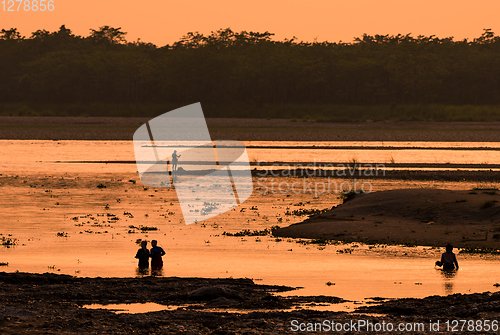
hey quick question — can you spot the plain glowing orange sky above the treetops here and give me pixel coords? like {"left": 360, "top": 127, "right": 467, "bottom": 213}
{"left": 0, "top": 0, "right": 500, "bottom": 46}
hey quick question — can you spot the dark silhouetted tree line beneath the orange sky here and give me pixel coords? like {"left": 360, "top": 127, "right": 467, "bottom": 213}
{"left": 0, "top": 26, "right": 500, "bottom": 117}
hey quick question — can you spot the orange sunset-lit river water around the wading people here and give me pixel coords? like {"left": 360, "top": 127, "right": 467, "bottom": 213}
{"left": 0, "top": 141, "right": 500, "bottom": 310}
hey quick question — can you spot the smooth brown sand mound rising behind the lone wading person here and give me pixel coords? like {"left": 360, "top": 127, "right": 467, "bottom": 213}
{"left": 273, "top": 189, "right": 500, "bottom": 249}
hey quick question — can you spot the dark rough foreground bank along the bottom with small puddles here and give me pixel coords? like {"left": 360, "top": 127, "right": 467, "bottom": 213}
{"left": 0, "top": 273, "right": 500, "bottom": 334}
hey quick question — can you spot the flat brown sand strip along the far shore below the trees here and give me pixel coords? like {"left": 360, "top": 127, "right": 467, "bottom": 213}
{"left": 0, "top": 116, "right": 500, "bottom": 142}
